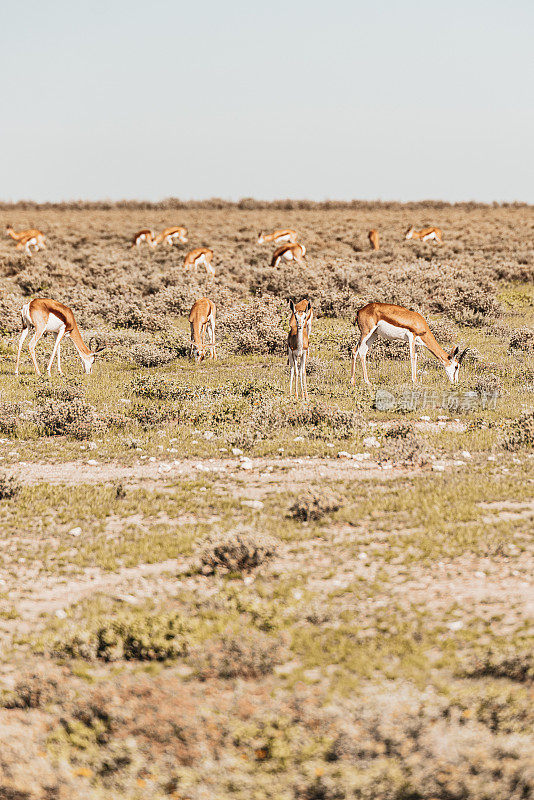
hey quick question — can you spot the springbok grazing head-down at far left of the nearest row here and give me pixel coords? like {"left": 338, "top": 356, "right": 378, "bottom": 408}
{"left": 15, "top": 297, "right": 105, "bottom": 375}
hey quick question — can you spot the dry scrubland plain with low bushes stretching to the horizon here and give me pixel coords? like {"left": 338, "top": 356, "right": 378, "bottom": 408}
{"left": 0, "top": 200, "right": 534, "bottom": 800}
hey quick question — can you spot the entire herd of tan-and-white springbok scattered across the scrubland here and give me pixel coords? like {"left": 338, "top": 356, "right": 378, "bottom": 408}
{"left": 7, "top": 226, "right": 467, "bottom": 400}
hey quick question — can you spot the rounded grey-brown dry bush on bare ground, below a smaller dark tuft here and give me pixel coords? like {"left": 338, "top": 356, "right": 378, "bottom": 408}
{"left": 198, "top": 532, "right": 277, "bottom": 575}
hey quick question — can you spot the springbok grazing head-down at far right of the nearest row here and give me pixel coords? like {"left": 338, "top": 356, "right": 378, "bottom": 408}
{"left": 350, "top": 303, "right": 467, "bottom": 385}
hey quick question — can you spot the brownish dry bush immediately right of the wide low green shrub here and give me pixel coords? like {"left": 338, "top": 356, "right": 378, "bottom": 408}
{"left": 189, "top": 629, "right": 288, "bottom": 680}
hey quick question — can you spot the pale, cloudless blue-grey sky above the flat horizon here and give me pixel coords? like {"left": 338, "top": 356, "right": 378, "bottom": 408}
{"left": 0, "top": 0, "right": 534, "bottom": 202}
